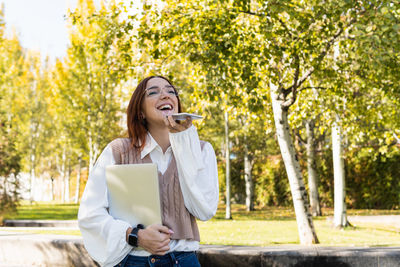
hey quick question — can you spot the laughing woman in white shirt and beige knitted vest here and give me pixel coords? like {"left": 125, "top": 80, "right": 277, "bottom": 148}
{"left": 78, "top": 76, "right": 218, "bottom": 266}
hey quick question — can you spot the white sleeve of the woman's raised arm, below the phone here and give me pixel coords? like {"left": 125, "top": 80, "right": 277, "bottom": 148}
{"left": 169, "top": 126, "right": 219, "bottom": 221}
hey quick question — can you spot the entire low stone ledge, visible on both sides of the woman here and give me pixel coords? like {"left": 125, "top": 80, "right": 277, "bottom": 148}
{"left": 0, "top": 236, "right": 400, "bottom": 267}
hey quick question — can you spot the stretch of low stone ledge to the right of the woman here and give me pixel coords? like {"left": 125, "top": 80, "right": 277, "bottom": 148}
{"left": 198, "top": 245, "right": 400, "bottom": 267}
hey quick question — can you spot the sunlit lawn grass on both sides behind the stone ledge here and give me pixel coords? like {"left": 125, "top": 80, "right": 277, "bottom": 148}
{"left": 1, "top": 203, "right": 400, "bottom": 246}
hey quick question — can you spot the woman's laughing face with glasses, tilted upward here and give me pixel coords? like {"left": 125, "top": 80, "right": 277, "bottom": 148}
{"left": 142, "top": 77, "right": 178, "bottom": 125}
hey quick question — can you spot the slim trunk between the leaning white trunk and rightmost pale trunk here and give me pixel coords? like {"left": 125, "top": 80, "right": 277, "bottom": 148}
{"left": 306, "top": 120, "right": 321, "bottom": 216}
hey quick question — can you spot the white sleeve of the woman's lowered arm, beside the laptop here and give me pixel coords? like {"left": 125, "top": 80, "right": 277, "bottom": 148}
{"left": 78, "top": 145, "right": 132, "bottom": 266}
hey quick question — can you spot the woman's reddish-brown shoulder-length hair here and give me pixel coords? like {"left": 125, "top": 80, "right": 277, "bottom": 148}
{"left": 126, "top": 76, "right": 182, "bottom": 151}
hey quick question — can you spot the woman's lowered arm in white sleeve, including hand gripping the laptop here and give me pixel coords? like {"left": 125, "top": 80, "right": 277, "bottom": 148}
{"left": 78, "top": 145, "right": 171, "bottom": 266}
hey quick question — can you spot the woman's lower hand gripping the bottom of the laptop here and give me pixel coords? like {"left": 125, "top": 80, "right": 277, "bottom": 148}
{"left": 138, "top": 224, "right": 173, "bottom": 255}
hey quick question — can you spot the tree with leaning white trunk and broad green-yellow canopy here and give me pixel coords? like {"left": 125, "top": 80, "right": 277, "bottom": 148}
{"left": 130, "top": 0, "right": 400, "bottom": 244}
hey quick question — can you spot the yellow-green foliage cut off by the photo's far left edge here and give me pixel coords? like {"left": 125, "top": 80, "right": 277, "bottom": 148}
{"left": 0, "top": 10, "right": 23, "bottom": 217}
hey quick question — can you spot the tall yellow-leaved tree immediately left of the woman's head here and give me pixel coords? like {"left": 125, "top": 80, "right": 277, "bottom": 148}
{"left": 61, "top": 0, "right": 132, "bottom": 174}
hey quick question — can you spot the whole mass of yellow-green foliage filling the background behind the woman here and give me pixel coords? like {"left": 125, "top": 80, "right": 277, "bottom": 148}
{"left": 0, "top": 0, "right": 400, "bottom": 215}
